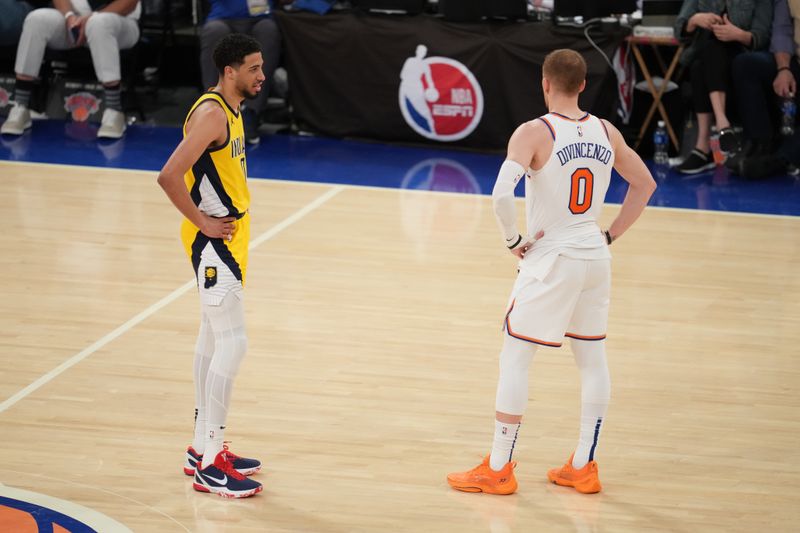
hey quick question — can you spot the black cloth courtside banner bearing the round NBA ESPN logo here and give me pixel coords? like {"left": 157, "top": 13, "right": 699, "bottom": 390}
{"left": 276, "top": 12, "right": 622, "bottom": 150}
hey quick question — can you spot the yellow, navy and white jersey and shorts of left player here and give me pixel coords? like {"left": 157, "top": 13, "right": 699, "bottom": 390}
{"left": 181, "top": 91, "right": 250, "bottom": 290}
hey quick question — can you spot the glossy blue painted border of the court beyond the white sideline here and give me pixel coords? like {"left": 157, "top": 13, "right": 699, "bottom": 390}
{"left": 0, "top": 120, "right": 800, "bottom": 216}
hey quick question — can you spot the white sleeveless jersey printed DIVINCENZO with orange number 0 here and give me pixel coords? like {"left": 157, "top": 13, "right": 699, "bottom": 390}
{"left": 520, "top": 113, "right": 614, "bottom": 277}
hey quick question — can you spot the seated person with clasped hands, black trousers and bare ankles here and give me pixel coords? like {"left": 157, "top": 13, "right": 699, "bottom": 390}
{"left": 675, "top": 0, "right": 773, "bottom": 174}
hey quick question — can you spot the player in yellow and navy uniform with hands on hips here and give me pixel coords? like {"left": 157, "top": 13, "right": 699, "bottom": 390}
{"left": 158, "top": 34, "right": 264, "bottom": 498}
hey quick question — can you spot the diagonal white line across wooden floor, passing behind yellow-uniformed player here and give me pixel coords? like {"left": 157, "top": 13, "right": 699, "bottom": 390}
{"left": 0, "top": 185, "right": 344, "bottom": 413}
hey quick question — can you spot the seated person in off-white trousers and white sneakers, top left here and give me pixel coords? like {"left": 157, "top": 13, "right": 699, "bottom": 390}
{"left": 0, "top": 0, "right": 141, "bottom": 139}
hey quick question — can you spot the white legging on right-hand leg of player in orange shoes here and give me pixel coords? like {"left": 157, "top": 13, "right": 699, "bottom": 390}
{"left": 572, "top": 339, "right": 611, "bottom": 469}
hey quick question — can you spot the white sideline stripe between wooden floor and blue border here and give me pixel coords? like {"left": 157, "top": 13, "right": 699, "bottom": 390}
{"left": 0, "top": 159, "right": 800, "bottom": 220}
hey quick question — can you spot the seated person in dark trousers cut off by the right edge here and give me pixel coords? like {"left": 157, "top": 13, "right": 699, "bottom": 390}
{"left": 726, "top": 0, "right": 800, "bottom": 175}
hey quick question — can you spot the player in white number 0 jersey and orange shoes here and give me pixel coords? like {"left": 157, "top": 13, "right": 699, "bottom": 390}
{"left": 447, "top": 50, "right": 656, "bottom": 494}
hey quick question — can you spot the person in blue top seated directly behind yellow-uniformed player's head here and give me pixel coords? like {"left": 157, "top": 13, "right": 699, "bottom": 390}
{"left": 200, "top": 0, "right": 293, "bottom": 144}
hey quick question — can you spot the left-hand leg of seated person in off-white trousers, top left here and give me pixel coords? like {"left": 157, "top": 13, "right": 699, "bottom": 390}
{"left": 0, "top": 8, "right": 72, "bottom": 135}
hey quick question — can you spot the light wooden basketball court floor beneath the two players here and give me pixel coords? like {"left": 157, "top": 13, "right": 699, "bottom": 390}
{"left": 0, "top": 162, "right": 800, "bottom": 532}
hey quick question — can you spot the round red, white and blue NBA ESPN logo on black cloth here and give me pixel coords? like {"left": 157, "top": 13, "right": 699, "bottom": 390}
{"left": 399, "top": 44, "right": 483, "bottom": 141}
